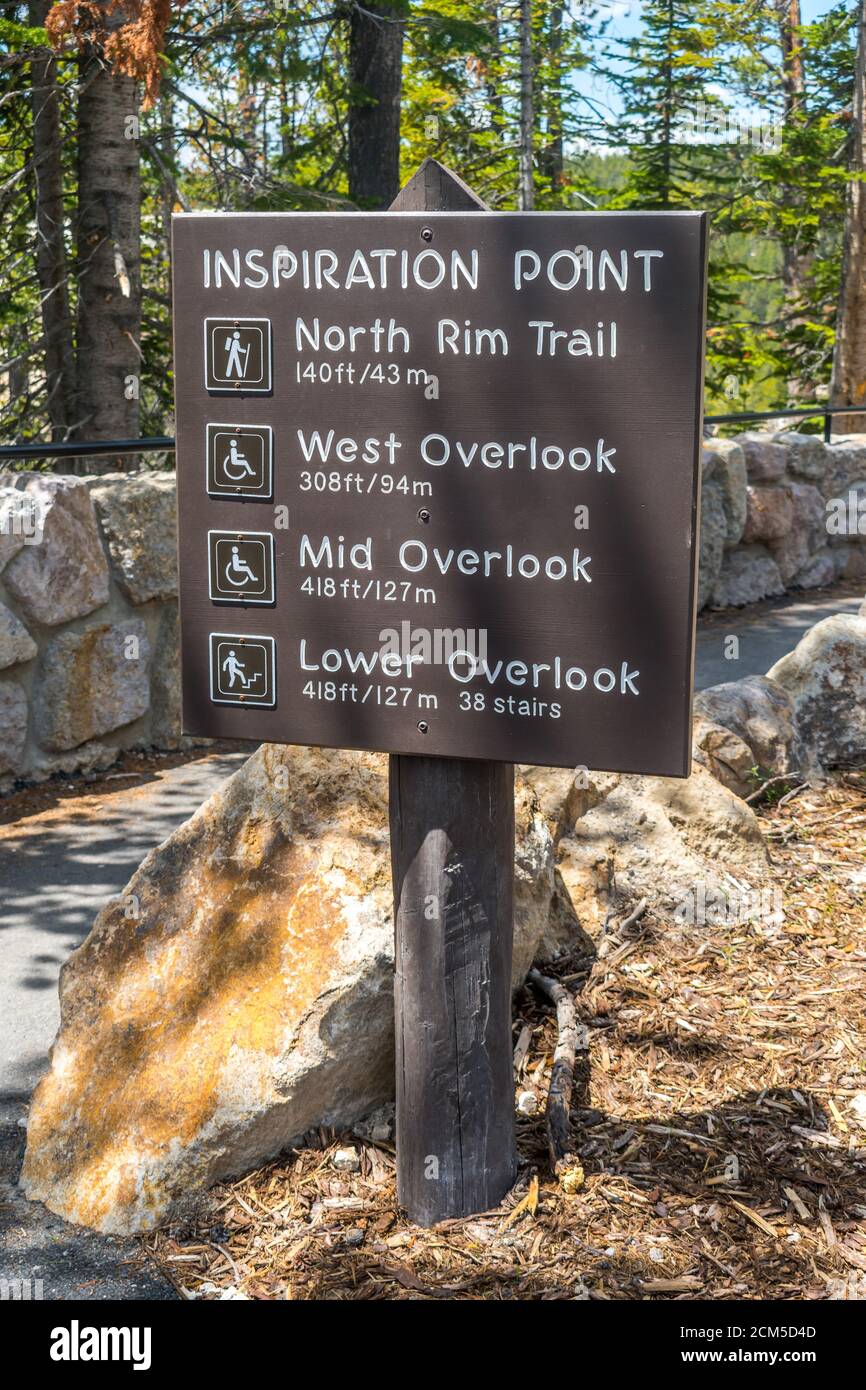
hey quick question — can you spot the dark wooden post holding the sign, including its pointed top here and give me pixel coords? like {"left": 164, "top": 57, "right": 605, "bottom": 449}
{"left": 389, "top": 160, "right": 517, "bottom": 1226}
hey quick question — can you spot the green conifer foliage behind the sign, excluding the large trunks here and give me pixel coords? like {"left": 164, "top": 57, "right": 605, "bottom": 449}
{"left": 0, "top": 0, "right": 855, "bottom": 441}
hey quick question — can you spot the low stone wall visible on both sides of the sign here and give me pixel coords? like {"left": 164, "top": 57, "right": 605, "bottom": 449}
{"left": 0, "top": 434, "right": 866, "bottom": 791}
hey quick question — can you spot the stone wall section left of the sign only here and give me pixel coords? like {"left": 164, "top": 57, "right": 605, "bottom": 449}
{"left": 0, "top": 473, "right": 179, "bottom": 791}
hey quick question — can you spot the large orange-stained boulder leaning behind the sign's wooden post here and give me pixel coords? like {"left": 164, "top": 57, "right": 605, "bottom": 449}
{"left": 22, "top": 745, "right": 553, "bottom": 1232}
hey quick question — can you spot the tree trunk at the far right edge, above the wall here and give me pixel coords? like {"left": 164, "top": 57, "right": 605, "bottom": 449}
{"left": 833, "top": 0, "right": 866, "bottom": 434}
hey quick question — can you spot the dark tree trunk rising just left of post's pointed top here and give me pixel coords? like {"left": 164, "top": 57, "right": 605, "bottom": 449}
{"left": 349, "top": 0, "right": 403, "bottom": 209}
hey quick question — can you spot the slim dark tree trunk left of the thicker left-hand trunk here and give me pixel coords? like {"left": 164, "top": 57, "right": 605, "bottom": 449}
{"left": 29, "top": 0, "right": 75, "bottom": 439}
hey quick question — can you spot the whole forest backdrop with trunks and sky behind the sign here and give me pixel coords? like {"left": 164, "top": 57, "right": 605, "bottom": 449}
{"left": 0, "top": 0, "right": 866, "bottom": 471}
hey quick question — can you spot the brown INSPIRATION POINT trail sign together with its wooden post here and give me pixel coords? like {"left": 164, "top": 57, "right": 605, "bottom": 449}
{"left": 174, "top": 160, "right": 706, "bottom": 1222}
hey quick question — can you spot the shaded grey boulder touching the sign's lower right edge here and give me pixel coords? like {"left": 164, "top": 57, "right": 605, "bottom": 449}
{"left": 694, "top": 676, "right": 808, "bottom": 796}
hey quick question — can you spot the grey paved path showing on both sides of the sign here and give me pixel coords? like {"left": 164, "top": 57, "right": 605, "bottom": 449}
{"left": 0, "top": 581, "right": 862, "bottom": 1298}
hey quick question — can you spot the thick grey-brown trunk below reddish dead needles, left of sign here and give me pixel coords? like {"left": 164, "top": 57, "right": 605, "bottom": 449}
{"left": 78, "top": 5, "right": 142, "bottom": 473}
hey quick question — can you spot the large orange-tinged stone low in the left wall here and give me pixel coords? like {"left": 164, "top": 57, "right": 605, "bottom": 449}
{"left": 38, "top": 617, "right": 150, "bottom": 752}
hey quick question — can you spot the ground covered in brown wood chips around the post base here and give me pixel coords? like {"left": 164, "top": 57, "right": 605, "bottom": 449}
{"left": 143, "top": 773, "right": 866, "bottom": 1300}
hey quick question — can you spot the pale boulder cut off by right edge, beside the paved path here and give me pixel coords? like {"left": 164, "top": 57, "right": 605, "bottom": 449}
{"left": 767, "top": 613, "right": 866, "bottom": 767}
